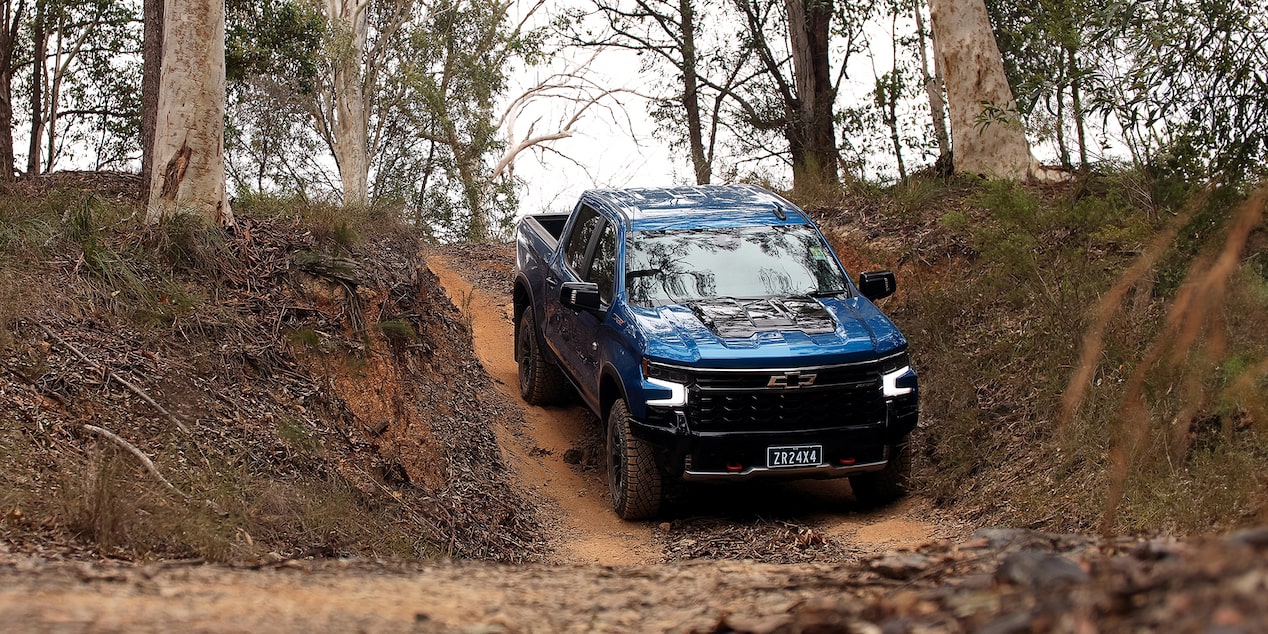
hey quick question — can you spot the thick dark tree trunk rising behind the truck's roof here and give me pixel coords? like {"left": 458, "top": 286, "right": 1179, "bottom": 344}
{"left": 785, "top": 0, "right": 841, "bottom": 191}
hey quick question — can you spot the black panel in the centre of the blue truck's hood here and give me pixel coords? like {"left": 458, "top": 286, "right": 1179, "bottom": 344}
{"left": 686, "top": 297, "right": 837, "bottom": 339}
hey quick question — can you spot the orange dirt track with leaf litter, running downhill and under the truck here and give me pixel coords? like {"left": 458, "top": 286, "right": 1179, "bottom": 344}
{"left": 427, "top": 245, "right": 971, "bottom": 566}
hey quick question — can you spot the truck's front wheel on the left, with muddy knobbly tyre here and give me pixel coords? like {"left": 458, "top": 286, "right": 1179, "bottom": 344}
{"left": 607, "top": 401, "right": 661, "bottom": 520}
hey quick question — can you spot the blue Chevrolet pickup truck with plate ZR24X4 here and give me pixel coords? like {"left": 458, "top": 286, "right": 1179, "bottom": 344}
{"left": 514, "top": 185, "right": 918, "bottom": 520}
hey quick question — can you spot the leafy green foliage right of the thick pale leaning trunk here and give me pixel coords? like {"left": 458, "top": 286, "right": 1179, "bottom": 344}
{"left": 987, "top": 0, "right": 1268, "bottom": 183}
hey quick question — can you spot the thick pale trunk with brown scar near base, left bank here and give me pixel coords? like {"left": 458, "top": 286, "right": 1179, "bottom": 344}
{"left": 146, "top": 0, "right": 233, "bottom": 227}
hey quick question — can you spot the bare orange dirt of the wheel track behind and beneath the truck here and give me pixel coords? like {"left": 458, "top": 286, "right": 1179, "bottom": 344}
{"left": 427, "top": 255, "right": 965, "bottom": 566}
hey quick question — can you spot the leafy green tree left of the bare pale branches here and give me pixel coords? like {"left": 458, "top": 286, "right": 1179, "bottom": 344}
{"left": 377, "top": 0, "right": 545, "bottom": 240}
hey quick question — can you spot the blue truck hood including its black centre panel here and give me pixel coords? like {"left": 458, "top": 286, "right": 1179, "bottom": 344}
{"left": 630, "top": 297, "right": 907, "bottom": 368}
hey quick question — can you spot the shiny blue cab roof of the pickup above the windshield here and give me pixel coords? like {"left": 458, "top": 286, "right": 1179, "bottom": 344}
{"left": 582, "top": 185, "right": 809, "bottom": 231}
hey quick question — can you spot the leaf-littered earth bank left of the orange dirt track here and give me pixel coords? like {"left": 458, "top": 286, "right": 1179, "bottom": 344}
{"left": 0, "top": 177, "right": 548, "bottom": 562}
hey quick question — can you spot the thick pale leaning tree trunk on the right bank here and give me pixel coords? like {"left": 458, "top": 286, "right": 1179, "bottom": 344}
{"left": 929, "top": 0, "right": 1038, "bottom": 179}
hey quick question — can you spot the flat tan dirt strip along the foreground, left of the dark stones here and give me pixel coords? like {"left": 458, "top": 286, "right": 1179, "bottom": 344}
{"left": 0, "top": 560, "right": 872, "bottom": 633}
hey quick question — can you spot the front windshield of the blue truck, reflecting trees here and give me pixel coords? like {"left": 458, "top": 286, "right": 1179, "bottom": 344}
{"left": 625, "top": 224, "right": 847, "bottom": 306}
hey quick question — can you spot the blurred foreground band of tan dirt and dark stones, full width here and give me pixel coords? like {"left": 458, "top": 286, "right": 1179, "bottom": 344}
{"left": 0, "top": 529, "right": 1268, "bottom": 634}
